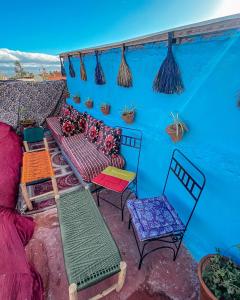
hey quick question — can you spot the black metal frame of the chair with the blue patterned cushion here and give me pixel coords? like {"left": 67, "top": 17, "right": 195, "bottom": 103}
{"left": 128, "top": 149, "right": 206, "bottom": 270}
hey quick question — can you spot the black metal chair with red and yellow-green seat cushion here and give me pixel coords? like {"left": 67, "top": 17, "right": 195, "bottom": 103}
{"left": 92, "top": 127, "right": 142, "bottom": 221}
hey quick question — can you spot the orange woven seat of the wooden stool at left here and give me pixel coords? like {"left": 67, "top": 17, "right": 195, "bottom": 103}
{"left": 21, "top": 151, "right": 54, "bottom": 183}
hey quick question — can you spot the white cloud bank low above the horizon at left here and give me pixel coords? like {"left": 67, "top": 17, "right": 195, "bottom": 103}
{"left": 0, "top": 48, "right": 60, "bottom": 73}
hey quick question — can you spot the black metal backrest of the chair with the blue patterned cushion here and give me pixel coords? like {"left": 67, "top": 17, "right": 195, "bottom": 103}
{"left": 163, "top": 149, "right": 206, "bottom": 228}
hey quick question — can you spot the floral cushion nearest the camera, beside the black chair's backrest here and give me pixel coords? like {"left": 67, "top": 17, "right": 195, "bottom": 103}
{"left": 98, "top": 126, "right": 122, "bottom": 157}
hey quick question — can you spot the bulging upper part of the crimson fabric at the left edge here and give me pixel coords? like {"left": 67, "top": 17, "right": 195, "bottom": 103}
{"left": 0, "top": 122, "right": 22, "bottom": 208}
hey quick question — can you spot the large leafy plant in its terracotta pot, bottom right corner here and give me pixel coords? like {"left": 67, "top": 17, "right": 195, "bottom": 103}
{"left": 198, "top": 245, "right": 240, "bottom": 300}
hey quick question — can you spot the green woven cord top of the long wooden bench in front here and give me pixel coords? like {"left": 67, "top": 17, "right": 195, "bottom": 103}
{"left": 57, "top": 189, "right": 121, "bottom": 290}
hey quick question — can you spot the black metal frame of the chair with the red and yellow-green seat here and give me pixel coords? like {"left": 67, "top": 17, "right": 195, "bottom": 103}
{"left": 92, "top": 126, "right": 142, "bottom": 221}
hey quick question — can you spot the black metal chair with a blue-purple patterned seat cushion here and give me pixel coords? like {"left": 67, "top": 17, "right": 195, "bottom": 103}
{"left": 127, "top": 149, "right": 206, "bottom": 269}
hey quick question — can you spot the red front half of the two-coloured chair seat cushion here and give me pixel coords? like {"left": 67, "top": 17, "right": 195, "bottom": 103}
{"left": 92, "top": 173, "right": 129, "bottom": 193}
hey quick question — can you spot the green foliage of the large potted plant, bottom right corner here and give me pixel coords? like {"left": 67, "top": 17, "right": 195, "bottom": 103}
{"left": 202, "top": 244, "right": 240, "bottom": 300}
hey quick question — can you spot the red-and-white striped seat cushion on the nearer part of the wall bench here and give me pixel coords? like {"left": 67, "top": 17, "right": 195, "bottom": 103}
{"left": 62, "top": 134, "right": 124, "bottom": 182}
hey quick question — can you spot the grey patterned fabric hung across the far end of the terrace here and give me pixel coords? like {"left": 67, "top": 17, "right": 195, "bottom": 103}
{"left": 0, "top": 80, "right": 66, "bottom": 128}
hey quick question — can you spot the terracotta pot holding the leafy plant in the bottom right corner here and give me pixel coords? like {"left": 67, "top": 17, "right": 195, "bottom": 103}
{"left": 198, "top": 255, "right": 217, "bottom": 300}
